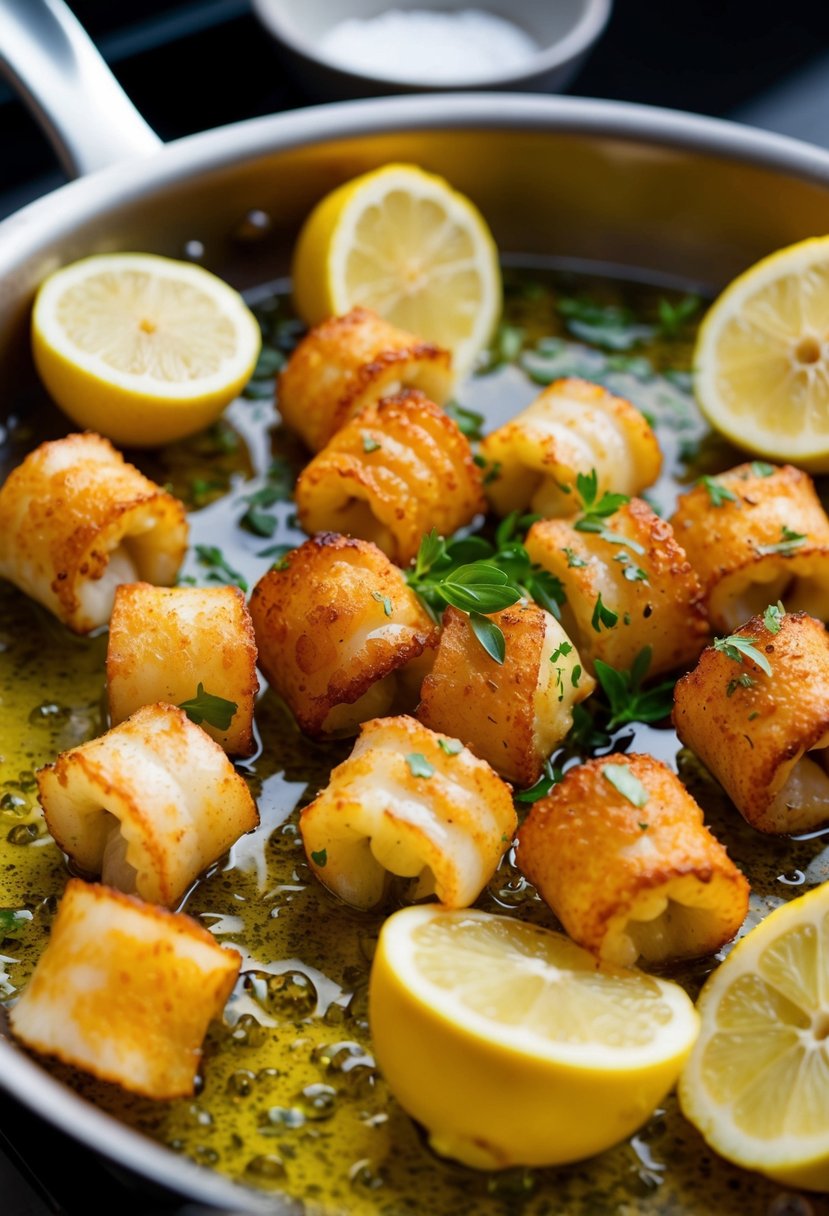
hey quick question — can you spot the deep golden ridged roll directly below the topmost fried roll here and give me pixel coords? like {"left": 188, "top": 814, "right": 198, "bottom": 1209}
{"left": 295, "top": 389, "right": 486, "bottom": 565}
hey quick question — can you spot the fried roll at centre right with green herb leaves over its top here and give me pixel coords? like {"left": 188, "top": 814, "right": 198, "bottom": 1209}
{"left": 417, "top": 603, "right": 596, "bottom": 786}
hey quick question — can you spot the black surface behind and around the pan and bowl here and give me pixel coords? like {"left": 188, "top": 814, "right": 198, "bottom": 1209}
{"left": 0, "top": 0, "right": 829, "bottom": 1216}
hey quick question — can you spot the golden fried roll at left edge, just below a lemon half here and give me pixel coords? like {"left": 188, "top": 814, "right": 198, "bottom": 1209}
{"left": 0, "top": 433, "right": 187, "bottom": 634}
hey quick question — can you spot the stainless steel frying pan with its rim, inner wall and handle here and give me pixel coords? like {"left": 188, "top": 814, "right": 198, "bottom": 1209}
{"left": 0, "top": 0, "right": 829, "bottom": 1214}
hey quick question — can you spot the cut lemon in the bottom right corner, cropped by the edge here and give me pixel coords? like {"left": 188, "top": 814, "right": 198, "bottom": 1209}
{"left": 679, "top": 883, "right": 829, "bottom": 1190}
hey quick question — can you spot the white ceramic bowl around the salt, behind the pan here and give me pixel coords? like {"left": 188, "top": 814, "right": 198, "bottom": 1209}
{"left": 253, "top": 0, "right": 613, "bottom": 100}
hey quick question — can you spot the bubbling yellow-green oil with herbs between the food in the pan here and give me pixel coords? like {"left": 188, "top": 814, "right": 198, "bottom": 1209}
{"left": 0, "top": 266, "right": 829, "bottom": 1216}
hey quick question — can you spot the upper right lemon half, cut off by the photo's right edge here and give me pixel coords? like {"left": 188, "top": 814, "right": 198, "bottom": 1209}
{"left": 694, "top": 236, "right": 829, "bottom": 472}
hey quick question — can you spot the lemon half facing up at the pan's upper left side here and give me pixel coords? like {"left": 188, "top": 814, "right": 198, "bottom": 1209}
{"left": 32, "top": 253, "right": 261, "bottom": 447}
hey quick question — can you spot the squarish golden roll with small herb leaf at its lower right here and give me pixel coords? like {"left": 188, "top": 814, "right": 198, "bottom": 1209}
{"left": 107, "top": 582, "right": 259, "bottom": 756}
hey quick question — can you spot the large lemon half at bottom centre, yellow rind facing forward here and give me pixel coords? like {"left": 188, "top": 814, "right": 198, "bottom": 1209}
{"left": 370, "top": 905, "right": 698, "bottom": 1169}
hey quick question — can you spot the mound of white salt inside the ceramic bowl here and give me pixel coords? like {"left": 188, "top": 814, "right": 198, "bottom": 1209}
{"left": 320, "top": 9, "right": 538, "bottom": 84}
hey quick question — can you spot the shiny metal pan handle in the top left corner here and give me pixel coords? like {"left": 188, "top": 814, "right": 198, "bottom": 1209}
{"left": 0, "top": 0, "right": 162, "bottom": 178}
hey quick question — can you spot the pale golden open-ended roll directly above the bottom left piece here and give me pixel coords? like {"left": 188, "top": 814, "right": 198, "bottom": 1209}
{"left": 38, "top": 705, "right": 259, "bottom": 907}
